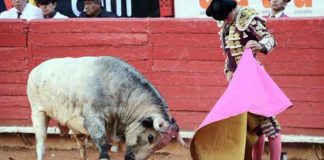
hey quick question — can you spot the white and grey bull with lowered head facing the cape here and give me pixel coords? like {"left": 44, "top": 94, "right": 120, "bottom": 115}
{"left": 27, "top": 56, "right": 184, "bottom": 160}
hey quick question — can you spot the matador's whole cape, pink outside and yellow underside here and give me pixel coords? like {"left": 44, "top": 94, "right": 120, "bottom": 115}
{"left": 190, "top": 49, "right": 292, "bottom": 160}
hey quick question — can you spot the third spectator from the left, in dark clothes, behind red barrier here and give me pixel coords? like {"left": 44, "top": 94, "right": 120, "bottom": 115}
{"left": 79, "top": 0, "right": 117, "bottom": 18}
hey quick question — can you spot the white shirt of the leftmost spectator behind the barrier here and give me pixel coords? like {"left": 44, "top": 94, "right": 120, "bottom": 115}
{"left": 0, "top": 3, "right": 43, "bottom": 20}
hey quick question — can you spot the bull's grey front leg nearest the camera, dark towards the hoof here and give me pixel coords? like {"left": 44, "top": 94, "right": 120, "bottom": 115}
{"left": 84, "top": 114, "right": 110, "bottom": 160}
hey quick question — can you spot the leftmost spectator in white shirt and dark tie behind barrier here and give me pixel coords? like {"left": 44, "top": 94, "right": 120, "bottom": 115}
{"left": 0, "top": 0, "right": 43, "bottom": 20}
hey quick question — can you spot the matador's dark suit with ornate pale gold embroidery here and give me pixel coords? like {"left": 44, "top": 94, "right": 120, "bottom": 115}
{"left": 220, "top": 8, "right": 280, "bottom": 141}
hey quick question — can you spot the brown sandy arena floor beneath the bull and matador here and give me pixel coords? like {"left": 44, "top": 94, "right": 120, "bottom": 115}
{"left": 0, "top": 134, "right": 324, "bottom": 160}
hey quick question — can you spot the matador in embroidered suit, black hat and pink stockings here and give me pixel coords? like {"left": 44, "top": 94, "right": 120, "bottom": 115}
{"left": 206, "top": 0, "right": 281, "bottom": 160}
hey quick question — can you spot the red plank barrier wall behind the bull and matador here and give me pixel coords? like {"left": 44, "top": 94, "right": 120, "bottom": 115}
{"left": 0, "top": 19, "right": 324, "bottom": 135}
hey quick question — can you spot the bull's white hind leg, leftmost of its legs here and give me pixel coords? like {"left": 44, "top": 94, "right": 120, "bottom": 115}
{"left": 32, "top": 111, "right": 50, "bottom": 160}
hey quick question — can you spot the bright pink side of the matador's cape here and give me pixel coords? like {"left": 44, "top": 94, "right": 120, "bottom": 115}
{"left": 199, "top": 49, "right": 292, "bottom": 128}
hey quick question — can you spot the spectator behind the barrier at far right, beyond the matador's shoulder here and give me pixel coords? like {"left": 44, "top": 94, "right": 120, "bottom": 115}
{"left": 267, "top": 0, "right": 290, "bottom": 18}
